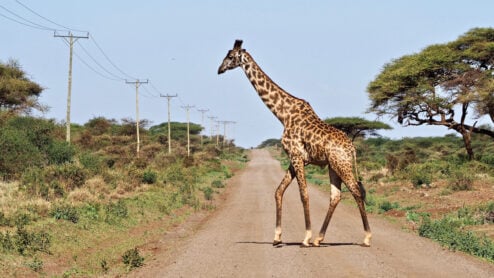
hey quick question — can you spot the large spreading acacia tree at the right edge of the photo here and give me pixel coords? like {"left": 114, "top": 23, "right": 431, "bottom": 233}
{"left": 367, "top": 28, "right": 494, "bottom": 159}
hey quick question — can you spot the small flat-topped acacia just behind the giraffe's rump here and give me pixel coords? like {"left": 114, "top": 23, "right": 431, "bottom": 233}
{"left": 324, "top": 117, "right": 392, "bottom": 141}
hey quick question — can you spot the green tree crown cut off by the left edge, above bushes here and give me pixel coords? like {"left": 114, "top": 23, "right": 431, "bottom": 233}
{"left": 0, "top": 60, "right": 45, "bottom": 113}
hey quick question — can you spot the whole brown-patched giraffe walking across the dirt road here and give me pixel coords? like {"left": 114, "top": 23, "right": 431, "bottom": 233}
{"left": 218, "top": 40, "right": 372, "bottom": 247}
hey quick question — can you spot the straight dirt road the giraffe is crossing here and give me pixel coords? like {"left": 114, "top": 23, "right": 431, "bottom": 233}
{"left": 131, "top": 150, "right": 494, "bottom": 277}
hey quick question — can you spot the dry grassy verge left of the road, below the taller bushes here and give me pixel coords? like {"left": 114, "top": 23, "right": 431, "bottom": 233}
{"left": 0, "top": 154, "right": 245, "bottom": 277}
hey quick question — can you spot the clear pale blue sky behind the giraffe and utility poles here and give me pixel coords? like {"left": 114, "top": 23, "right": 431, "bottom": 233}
{"left": 0, "top": 0, "right": 494, "bottom": 147}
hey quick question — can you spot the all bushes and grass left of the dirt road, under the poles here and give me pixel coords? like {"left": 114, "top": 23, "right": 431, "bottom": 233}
{"left": 0, "top": 113, "right": 247, "bottom": 276}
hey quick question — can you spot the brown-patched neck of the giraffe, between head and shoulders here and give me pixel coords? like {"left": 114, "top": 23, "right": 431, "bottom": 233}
{"left": 242, "top": 52, "right": 299, "bottom": 123}
